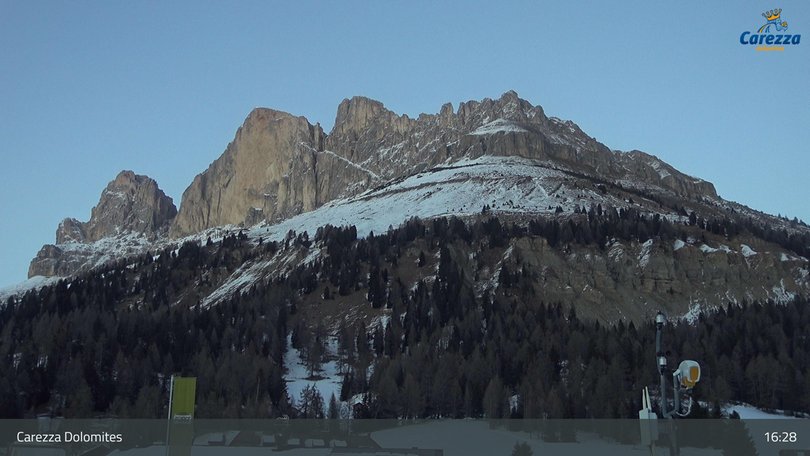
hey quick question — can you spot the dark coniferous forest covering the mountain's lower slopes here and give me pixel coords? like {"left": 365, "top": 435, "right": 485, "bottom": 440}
{"left": 0, "top": 208, "right": 810, "bottom": 418}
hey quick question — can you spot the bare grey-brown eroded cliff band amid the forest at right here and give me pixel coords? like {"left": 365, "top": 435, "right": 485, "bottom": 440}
{"left": 502, "top": 237, "right": 810, "bottom": 322}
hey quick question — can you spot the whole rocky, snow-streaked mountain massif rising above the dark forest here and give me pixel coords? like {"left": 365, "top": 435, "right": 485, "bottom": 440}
{"left": 29, "top": 91, "right": 810, "bottom": 290}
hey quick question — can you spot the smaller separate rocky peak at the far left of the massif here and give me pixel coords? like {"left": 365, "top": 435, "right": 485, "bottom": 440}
{"left": 28, "top": 171, "right": 177, "bottom": 277}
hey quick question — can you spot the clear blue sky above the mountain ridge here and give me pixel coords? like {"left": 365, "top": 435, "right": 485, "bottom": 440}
{"left": 0, "top": 0, "right": 810, "bottom": 286}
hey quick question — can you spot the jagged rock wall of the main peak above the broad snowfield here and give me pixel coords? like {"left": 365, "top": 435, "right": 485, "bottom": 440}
{"left": 171, "top": 91, "right": 717, "bottom": 237}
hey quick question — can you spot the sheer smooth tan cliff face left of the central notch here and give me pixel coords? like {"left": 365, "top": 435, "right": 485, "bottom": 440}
{"left": 171, "top": 109, "right": 324, "bottom": 236}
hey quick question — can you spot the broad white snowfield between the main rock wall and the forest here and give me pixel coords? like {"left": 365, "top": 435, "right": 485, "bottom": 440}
{"left": 243, "top": 156, "right": 604, "bottom": 244}
